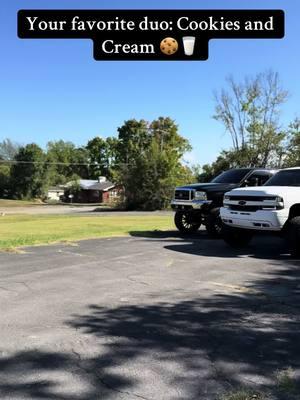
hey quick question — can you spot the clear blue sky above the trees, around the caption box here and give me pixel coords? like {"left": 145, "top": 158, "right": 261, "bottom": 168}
{"left": 0, "top": 0, "right": 300, "bottom": 164}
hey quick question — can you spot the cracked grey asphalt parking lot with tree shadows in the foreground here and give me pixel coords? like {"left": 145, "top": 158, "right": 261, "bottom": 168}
{"left": 0, "top": 232, "right": 300, "bottom": 400}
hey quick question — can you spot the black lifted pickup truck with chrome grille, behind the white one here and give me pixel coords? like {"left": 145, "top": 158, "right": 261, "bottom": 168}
{"left": 171, "top": 168, "right": 277, "bottom": 237}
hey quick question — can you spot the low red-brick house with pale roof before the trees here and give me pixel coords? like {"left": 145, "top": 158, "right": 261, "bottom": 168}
{"left": 67, "top": 176, "right": 122, "bottom": 203}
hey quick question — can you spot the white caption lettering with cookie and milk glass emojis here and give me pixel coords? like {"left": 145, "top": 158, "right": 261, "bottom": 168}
{"left": 22, "top": 15, "right": 273, "bottom": 56}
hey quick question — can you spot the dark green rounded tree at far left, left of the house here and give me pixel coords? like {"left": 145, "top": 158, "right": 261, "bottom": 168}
{"left": 11, "top": 143, "right": 48, "bottom": 199}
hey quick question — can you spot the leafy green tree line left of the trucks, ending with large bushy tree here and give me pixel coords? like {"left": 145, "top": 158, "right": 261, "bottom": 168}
{"left": 0, "top": 117, "right": 195, "bottom": 210}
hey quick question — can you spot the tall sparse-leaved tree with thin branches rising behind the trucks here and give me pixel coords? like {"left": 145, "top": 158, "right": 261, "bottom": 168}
{"left": 214, "top": 71, "right": 288, "bottom": 167}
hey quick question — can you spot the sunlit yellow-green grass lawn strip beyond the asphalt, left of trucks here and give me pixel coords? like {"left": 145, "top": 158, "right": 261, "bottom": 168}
{"left": 0, "top": 213, "right": 173, "bottom": 250}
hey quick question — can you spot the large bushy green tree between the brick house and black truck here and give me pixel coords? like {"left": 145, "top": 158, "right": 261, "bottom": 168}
{"left": 118, "top": 118, "right": 193, "bottom": 210}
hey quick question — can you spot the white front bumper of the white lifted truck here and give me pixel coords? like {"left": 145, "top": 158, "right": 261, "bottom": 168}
{"left": 221, "top": 207, "right": 288, "bottom": 232}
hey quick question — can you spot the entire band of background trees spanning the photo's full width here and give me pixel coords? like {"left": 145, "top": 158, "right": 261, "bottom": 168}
{"left": 0, "top": 71, "right": 300, "bottom": 210}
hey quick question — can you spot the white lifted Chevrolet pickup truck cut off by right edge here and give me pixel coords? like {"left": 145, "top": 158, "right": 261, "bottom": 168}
{"left": 220, "top": 167, "right": 300, "bottom": 256}
